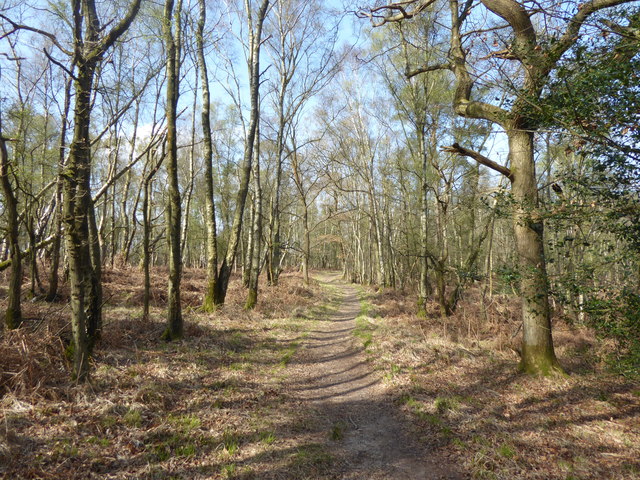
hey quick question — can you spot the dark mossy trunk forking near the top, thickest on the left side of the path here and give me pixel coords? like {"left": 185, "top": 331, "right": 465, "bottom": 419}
{"left": 62, "top": 0, "right": 141, "bottom": 381}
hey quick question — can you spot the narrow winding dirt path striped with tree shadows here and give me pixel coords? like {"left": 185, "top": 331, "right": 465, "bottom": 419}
{"left": 290, "top": 276, "right": 465, "bottom": 480}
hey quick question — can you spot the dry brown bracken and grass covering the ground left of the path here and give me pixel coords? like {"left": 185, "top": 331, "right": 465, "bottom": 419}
{"left": 0, "top": 269, "right": 329, "bottom": 479}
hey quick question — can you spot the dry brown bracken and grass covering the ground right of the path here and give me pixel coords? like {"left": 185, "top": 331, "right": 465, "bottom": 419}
{"left": 362, "top": 284, "right": 640, "bottom": 480}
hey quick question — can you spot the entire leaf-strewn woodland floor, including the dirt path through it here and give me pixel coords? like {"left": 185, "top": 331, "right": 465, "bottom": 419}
{"left": 0, "top": 268, "right": 640, "bottom": 480}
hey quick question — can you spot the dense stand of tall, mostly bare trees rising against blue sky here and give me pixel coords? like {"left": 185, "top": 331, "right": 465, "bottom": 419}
{"left": 0, "top": 0, "right": 640, "bottom": 380}
